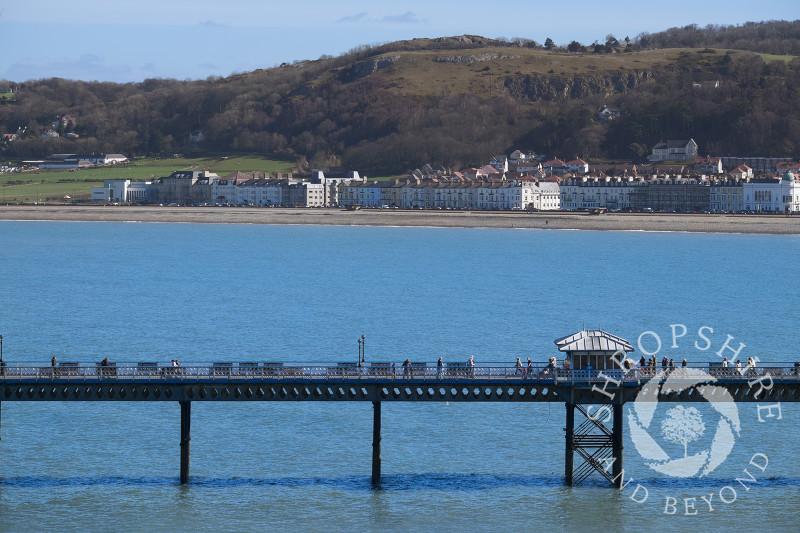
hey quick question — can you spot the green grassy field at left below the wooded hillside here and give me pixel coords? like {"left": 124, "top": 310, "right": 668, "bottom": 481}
{"left": 0, "top": 156, "right": 296, "bottom": 203}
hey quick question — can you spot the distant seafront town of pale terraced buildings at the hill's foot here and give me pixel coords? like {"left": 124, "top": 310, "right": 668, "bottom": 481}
{"left": 4, "top": 139, "right": 800, "bottom": 214}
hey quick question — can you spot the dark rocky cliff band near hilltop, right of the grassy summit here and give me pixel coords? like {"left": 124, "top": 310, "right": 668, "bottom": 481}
{"left": 504, "top": 71, "right": 655, "bottom": 101}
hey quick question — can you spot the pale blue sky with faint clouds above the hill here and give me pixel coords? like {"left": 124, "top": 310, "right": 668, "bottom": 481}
{"left": 0, "top": 0, "right": 800, "bottom": 82}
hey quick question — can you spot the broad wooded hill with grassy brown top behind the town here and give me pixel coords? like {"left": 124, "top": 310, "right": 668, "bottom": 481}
{"left": 0, "top": 21, "right": 800, "bottom": 174}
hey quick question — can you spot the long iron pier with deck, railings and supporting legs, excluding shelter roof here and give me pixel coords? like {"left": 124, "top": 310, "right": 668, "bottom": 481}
{"left": 0, "top": 354, "right": 800, "bottom": 486}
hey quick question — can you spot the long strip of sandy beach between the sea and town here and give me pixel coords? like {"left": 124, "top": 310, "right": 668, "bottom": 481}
{"left": 0, "top": 205, "right": 800, "bottom": 234}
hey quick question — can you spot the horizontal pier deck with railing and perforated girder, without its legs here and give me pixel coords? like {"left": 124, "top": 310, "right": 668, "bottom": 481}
{"left": 0, "top": 362, "right": 800, "bottom": 404}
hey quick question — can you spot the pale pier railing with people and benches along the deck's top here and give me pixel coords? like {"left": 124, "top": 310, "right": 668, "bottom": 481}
{"left": 0, "top": 362, "right": 800, "bottom": 384}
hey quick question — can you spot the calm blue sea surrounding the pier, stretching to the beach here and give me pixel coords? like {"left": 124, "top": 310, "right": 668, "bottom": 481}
{"left": 0, "top": 221, "right": 800, "bottom": 532}
